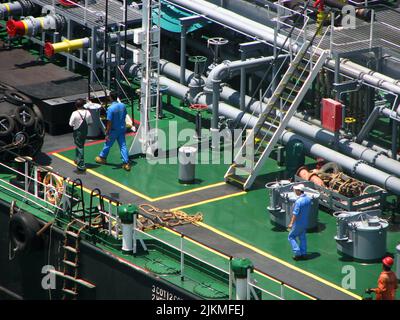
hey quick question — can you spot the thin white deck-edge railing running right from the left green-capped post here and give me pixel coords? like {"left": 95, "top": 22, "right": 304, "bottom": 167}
{"left": 135, "top": 222, "right": 296, "bottom": 300}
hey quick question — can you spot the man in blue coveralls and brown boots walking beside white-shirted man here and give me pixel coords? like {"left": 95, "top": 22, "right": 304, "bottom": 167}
{"left": 95, "top": 92, "right": 131, "bottom": 171}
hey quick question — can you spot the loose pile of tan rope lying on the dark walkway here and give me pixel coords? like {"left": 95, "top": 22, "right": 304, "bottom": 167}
{"left": 138, "top": 203, "right": 203, "bottom": 231}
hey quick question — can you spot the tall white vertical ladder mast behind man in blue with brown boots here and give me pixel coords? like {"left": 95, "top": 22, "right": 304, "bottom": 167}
{"left": 129, "top": 0, "right": 161, "bottom": 155}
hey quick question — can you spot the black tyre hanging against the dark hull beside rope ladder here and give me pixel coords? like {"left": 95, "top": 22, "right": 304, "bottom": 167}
{"left": 9, "top": 212, "right": 41, "bottom": 252}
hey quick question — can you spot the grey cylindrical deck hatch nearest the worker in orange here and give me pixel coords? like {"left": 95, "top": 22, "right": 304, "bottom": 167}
{"left": 333, "top": 210, "right": 389, "bottom": 261}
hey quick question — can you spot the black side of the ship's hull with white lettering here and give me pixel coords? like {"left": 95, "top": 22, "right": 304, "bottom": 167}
{"left": 0, "top": 200, "right": 199, "bottom": 300}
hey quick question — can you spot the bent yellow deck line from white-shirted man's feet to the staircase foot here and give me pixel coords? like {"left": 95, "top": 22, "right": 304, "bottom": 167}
{"left": 52, "top": 153, "right": 234, "bottom": 202}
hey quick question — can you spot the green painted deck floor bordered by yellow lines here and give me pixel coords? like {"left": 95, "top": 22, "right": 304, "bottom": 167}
{"left": 45, "top": 102, "right": 400, "bottom": 297}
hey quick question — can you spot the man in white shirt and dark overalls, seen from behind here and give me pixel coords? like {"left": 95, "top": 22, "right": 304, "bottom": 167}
{"left": 69, "top": 99, "right": 93, "bottom": 172}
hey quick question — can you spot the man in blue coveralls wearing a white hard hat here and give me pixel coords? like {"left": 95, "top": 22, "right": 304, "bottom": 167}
{"left": 288, "top": 184, "right": 311, "bottom": 261}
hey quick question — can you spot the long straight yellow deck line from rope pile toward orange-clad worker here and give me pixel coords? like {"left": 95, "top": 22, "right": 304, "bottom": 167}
{"left": 197, "top": 222, "right": 362, "bottom": 300}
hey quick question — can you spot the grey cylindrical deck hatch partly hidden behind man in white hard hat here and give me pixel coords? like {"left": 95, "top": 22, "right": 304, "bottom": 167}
{"left": 266, "top": 180, "right": 320, "bottom": 230}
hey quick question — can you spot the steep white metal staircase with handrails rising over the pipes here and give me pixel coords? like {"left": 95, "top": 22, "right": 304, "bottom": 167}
{"left": 225, "top": 32, "right": 329, "bottom": 190}
